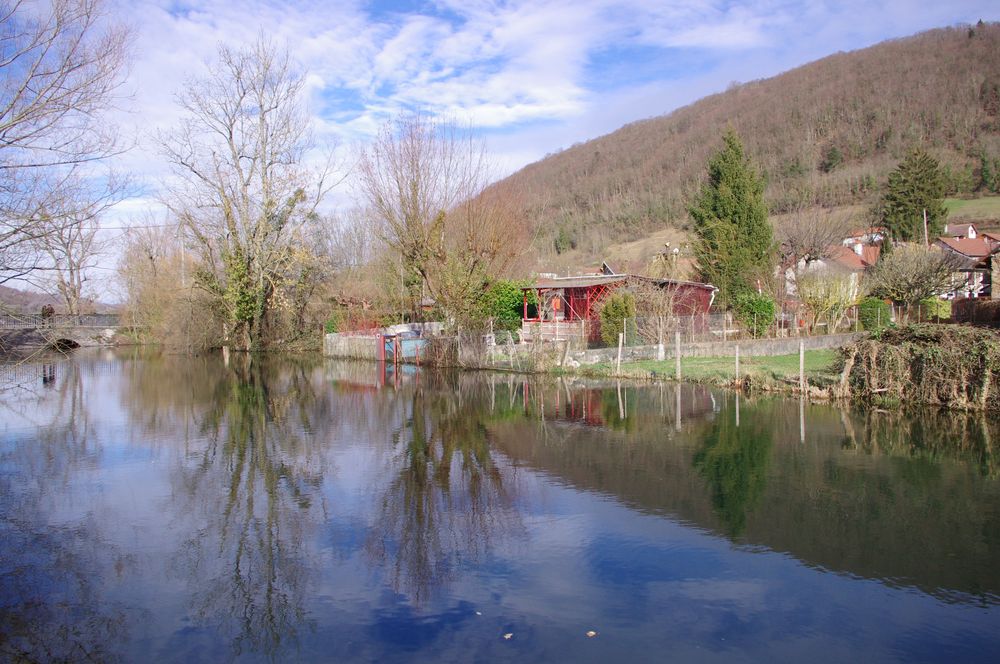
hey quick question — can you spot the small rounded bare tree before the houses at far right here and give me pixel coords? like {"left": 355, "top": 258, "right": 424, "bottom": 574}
{"left": 867, "top": 244, "right": 960, "bottom": 310}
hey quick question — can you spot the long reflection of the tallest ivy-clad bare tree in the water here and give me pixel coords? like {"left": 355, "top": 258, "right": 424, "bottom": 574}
{"left": 169, "top": 355, "right": 323, "bottom": 659}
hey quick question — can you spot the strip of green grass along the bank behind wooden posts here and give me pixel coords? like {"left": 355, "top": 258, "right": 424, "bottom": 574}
{"left": 582, "top": 350, "right": 837, "bottom": 383}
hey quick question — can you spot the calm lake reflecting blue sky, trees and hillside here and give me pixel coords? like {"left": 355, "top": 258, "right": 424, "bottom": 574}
{"left": 0, "top": 351, "right": 1000, "bottom": 662}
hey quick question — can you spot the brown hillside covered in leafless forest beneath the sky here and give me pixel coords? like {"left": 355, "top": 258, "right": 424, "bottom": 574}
{"left": 509, "top": 24, "right": 1000, "bottom": 256}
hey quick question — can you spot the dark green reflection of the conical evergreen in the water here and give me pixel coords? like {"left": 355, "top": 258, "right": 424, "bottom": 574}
{"left": 694, "top": 404, "right": 772, "bottom": 537}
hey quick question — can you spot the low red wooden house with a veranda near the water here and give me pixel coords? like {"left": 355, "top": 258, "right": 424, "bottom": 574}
{"left": 522, "top": 272, "right": 718, "bottom": 339}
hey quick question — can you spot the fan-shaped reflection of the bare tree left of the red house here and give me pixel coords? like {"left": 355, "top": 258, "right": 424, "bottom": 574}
{"left": 366, "top": 386, "right": 522, "bottom": 603}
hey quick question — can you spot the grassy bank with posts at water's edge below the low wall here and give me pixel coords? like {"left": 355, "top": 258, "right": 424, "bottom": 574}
{"left": 577, "top": 350, "right": 839, "bottom": 389}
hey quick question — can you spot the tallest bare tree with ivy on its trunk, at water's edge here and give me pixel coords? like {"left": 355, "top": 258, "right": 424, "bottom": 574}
{"left": 160, "top": 37, "right": 335, "bottom": 350}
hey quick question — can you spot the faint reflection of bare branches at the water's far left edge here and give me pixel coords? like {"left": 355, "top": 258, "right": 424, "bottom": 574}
{"left": 0, "top": 363, "right": 128, "bottom": 661}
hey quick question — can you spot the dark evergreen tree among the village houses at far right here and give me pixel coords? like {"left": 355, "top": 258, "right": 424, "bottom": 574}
{"left": 878, "top": 149, "right": 948, "bottom": 242}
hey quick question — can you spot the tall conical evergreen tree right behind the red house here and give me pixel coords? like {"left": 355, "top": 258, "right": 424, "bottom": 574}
{"left": 688, "top": 129, "right": 774, "bottom": 304}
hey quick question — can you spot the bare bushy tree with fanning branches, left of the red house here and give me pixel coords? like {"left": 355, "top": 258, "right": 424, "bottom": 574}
{"left": 359, "top": 115, "right": 527, "bottom": 317}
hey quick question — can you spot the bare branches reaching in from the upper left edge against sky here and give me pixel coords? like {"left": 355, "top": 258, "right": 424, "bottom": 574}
{"left": 0, "top": 0, "right": 129, "bottom": 283}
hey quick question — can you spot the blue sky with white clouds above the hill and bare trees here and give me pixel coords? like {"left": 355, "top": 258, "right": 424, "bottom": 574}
{"left": 84, "top": 0, "right": 1000, "bottom": 294}
